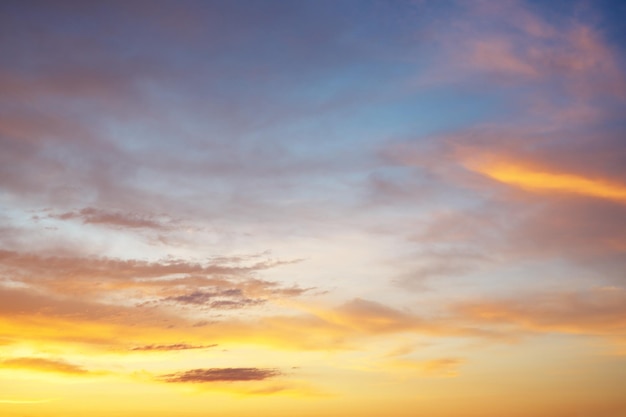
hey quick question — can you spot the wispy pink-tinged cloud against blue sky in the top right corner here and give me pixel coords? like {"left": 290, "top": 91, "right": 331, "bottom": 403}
{"left": 438, "top": 1, "right": 626, "bottom": 99}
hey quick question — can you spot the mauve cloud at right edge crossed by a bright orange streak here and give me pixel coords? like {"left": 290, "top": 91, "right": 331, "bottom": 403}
{"left": 448, "top": 132, "right": 626, "bottom": 272}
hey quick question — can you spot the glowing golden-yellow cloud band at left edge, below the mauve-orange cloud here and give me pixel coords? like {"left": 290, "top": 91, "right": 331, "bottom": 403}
{"left": 0, "top": 286, "right": 199, "bottom": 351}
